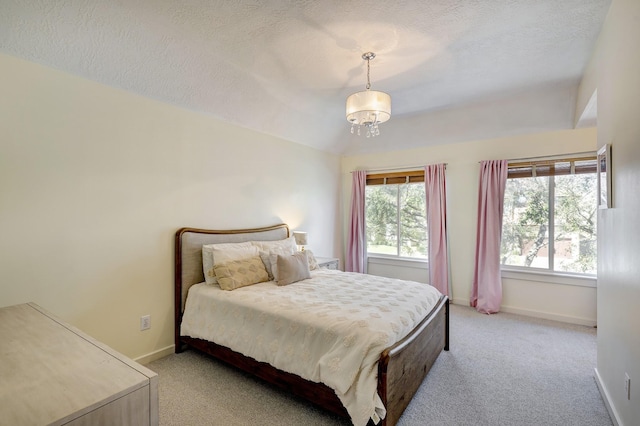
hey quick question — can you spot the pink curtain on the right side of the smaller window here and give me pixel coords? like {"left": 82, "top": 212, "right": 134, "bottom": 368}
{"left": 424, "top": 164, "right": 449, "bottom": 296}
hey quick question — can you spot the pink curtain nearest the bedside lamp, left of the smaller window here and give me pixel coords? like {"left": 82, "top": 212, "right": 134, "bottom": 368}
{"left": 345, "top": 170, "right": 367, "bottom": 273}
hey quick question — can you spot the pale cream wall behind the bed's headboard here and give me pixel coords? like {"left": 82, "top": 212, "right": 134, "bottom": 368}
{"left": 0, "top": 51, "right": 341, "bottom": 358}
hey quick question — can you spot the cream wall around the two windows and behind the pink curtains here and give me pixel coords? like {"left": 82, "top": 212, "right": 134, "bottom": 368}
{"left": 342, "top": 128, "right": 597, "bottom": 325}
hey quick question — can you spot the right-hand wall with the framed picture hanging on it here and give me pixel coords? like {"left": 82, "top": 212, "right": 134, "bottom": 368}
{"left": 594, "top": 0, "right": 640, "bottom": 425}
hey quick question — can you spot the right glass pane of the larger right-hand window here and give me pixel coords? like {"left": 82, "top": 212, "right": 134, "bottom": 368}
{"left": 554, "top": 174, "right": 597, "bottom": 274}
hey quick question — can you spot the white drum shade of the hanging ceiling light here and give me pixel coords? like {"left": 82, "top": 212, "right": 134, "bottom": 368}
{"left": 347, "top": 90, "right": 391, "bottom": 126}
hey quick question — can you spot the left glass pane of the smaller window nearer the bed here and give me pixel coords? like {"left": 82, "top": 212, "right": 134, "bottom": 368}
{"left": 365, "top": 185, "right": 398, "bottom": 255}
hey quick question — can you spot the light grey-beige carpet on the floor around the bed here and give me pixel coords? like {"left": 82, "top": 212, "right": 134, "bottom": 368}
{"left": 147, "top": 305, "right": 612, "bottom": 426}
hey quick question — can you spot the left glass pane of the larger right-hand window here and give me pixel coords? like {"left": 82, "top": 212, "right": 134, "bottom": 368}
{"left": 501, "top": 177, "right": 549, "bottom": 269}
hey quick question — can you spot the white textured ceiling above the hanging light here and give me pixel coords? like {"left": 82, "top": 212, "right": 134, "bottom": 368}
{"left": 0, "top": 0, "right": 611, "bottom": 155}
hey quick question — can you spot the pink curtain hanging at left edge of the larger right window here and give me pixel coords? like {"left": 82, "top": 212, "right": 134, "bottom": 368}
{"left": 471, "top": 160, "right": 507, "bottom": 314}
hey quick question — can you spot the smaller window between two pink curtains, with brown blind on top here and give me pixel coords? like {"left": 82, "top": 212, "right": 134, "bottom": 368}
{"left": 365, "top": 171, "right": 427, "bottom": 260}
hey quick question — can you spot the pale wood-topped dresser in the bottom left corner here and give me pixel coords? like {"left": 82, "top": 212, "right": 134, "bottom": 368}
{"left": 0, "top": 303, "right": 158, "bottom": 426}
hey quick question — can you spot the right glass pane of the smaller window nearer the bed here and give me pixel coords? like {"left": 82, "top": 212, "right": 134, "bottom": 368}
{"left": 399, "top": 183, "right": 427, "bottom": 259}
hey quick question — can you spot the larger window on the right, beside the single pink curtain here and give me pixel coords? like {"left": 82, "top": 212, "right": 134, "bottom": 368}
{"left": 501, "top": 156, "right": 597, "bottom": 274}
